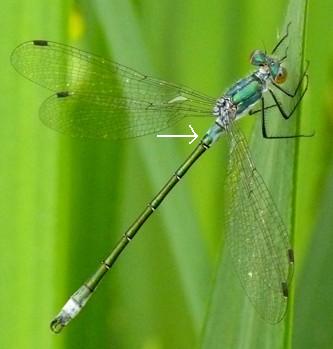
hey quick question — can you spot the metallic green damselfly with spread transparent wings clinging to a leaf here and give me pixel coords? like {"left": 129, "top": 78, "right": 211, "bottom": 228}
{"left": 11, "top": 21, "right": 308, "bottom": 332}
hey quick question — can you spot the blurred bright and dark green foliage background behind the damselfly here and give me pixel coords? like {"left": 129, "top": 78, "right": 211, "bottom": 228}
{"left": 0, "top": 0, "right": 333, "bottom": 349}
